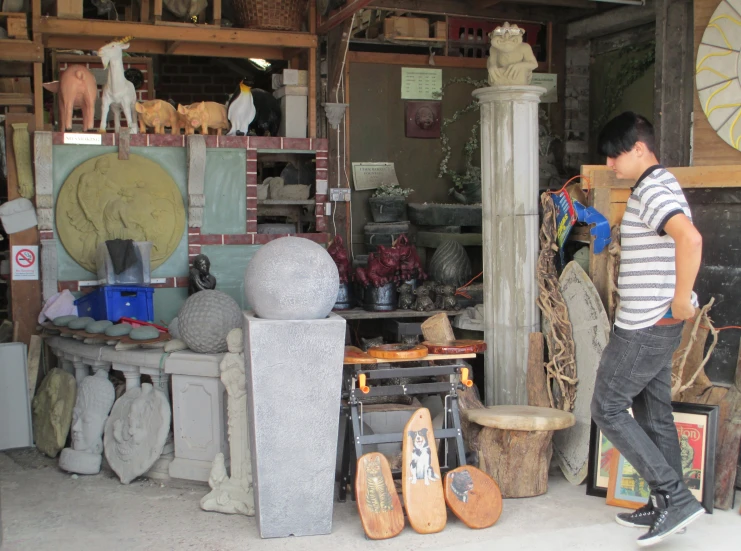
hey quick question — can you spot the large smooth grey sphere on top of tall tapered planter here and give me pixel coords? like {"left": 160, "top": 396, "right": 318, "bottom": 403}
{"left": 244, "top": 237, "right": 340, "bottom": 322}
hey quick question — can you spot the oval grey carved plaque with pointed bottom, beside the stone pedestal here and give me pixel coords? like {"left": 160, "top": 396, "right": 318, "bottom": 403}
{"left": 103, "top": 383, "right": 171, "bottom": 484}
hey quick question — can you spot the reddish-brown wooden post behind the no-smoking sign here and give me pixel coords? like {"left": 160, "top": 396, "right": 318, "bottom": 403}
{"left": 5, "top": 113, "right": 41, "bottom": 345}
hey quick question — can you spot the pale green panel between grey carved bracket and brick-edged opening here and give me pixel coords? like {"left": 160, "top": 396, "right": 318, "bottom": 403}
{"left": 201, "top": 149, "right": 247, "bottom": 234}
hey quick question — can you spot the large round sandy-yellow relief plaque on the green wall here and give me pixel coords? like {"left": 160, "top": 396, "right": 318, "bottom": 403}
{"left": 55, "top": 153, "right": 185, "bottom": 273}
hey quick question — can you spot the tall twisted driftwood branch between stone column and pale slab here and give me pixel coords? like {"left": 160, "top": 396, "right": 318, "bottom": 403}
{"left": 537, "top": 193, "right": 578, "bottom": 411}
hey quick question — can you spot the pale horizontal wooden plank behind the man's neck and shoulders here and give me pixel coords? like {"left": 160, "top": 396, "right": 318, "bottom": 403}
{"left": 581, "top": 165, "right": 741, "bottom": 189}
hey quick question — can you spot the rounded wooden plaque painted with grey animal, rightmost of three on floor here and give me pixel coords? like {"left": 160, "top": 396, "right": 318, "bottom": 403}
{"left": 445, "top": 465, "right": 502, "bottom": 528}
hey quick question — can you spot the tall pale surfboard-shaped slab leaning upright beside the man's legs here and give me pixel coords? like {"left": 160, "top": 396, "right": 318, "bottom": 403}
{"left": 553, "top": 262, "right": 610, "bottom": 484}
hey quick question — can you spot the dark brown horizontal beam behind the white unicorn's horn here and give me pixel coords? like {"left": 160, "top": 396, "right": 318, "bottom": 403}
{"left": 46, "top": 36, "right": 284, "bottom": 60}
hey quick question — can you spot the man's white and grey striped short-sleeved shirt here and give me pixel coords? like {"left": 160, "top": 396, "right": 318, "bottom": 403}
{"left": 615, "top": 165, "right": 696, "bottom": 329}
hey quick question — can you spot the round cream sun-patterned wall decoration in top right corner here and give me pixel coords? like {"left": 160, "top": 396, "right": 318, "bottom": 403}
{"left": 695, "top": 0, "right": 741, "bottom": 150}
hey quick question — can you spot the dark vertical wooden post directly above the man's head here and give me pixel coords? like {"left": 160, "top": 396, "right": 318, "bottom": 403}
{"left": 653, "top": 0, "right": 695, "bottom": 166}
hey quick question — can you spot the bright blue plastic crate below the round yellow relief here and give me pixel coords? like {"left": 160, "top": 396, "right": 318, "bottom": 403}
{"left": 75, "top": 285, "right": 154, "bottom": 322}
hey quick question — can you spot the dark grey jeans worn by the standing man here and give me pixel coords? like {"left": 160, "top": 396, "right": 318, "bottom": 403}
{"left": 592, "top": 326, "right": 692, "bottom": 502}
